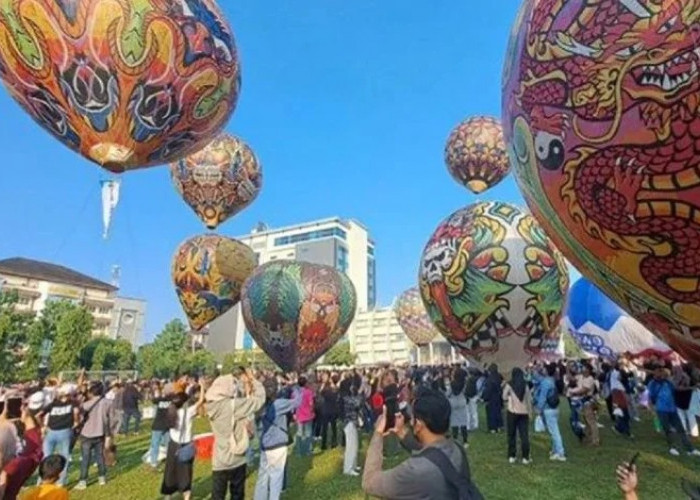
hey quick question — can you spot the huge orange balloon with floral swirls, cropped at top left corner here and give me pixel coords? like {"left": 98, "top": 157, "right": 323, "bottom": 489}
{"left": 0, "top": 0, "right": 240, "bottom": 172}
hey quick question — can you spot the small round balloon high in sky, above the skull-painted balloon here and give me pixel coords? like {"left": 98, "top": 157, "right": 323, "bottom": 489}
{"left": 445, "top": 116, "right": 510, "bottom": 194}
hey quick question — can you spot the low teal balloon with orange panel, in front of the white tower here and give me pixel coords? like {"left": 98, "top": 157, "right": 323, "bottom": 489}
{"left": 241, "top": 260, "right": 357, "bottom": 372}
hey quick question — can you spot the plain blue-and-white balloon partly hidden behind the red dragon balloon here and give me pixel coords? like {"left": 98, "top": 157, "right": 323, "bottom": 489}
{"left": 564, "top": 278, "right": 673, "bottom": 359}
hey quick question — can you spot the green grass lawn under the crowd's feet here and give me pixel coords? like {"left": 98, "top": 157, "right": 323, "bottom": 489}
{"left": 58, "top": 408, "right": 700, "bottom": 500}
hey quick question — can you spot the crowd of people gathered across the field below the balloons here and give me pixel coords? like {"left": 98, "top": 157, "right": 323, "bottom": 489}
{"left": 0, "top": 356, "right": 700, "bottom": 500}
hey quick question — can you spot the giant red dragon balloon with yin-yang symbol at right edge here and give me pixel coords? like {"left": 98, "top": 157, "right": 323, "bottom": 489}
{"left": 502, "top": 0, "right": 700, "bottom": 362}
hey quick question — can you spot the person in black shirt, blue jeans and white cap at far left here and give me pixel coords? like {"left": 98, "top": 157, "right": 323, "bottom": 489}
{"left": 43, "top": 385, "right": 78, "bottom": 486}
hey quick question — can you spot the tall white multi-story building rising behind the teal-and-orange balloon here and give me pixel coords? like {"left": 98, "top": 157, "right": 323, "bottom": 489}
{"left": 207, "top": 217, "right": 376, "bottom": 355}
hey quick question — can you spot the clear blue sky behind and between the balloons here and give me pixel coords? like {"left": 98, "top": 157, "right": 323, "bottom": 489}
{"left": 0, "top": 0, "right": 580, "bottom": 340}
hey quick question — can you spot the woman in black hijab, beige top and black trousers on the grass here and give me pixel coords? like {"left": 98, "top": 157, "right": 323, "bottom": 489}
{"left": 503, "top": 367, "right": 532, "bottom": 465}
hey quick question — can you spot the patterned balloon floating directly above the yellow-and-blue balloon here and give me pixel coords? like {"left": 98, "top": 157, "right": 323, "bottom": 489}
{"left": 170, "top": 134, "right": 262, "bottom": 229}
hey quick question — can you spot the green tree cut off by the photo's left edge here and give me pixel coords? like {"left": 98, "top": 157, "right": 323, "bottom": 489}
{"left": 0, "top": 291, "right": 34, "bottom": 382}
